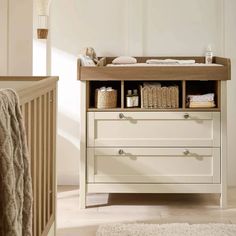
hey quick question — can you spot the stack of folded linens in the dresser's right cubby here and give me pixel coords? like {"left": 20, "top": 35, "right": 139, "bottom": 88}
{"left": 188, "top": 93, "right": 216, "bottom": 108}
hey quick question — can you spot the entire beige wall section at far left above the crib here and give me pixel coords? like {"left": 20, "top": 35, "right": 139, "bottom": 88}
{"left": 0, "top": 0, "right": 33, "bottom": 75}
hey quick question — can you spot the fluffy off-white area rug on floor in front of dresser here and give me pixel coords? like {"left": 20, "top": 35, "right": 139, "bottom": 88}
{"left": 96, "top": 223, "right": 236, "bottom": 236}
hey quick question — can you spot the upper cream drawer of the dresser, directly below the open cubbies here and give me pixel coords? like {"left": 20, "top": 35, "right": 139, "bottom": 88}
{"left": 87, "top": 112, "right": 220, "bottom": 147}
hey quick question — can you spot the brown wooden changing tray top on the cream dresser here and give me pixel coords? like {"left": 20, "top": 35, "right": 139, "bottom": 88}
{"left": 78, "top": 57, "right": 231, "bottom": 81}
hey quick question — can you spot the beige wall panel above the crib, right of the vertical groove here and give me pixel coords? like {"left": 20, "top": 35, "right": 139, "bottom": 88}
{"left": 8, "top": 0, "right": 33, "bottom": 75}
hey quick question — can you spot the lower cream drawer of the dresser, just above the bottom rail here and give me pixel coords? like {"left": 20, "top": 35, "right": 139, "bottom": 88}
{"left": 87, "top": 148, "right": 220, "bottom": 184}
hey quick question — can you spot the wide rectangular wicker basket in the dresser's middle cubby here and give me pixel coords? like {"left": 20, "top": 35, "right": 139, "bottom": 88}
{"left": 140, "top": 86, "right": 179, "bottom": 109}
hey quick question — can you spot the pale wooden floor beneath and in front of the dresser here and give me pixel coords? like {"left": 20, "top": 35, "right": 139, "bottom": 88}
{"left": 57, "top": 186, "right": 236, "bottom": 236}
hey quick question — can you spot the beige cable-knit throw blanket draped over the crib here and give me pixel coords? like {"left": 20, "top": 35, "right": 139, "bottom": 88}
{"left": 0, "top": 89, "right": 33, "bottom": 236}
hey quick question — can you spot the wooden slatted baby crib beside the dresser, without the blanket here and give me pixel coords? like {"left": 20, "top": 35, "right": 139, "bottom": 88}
{"left": 0, "top": 77, "right": 58, "bottom": 236}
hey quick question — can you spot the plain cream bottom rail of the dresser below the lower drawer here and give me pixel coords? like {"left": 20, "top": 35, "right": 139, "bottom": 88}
{"left": 87, "top": 184, "right": 221, "bottom": 193}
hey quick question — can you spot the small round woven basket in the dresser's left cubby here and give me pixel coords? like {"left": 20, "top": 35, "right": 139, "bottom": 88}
{"left": 95, "top": 89, "right": 117, "bottom": 109}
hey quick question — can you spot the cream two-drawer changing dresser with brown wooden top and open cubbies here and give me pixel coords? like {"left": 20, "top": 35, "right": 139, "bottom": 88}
{"left": 78, "top": 58, "right": 230, "bottom": 208}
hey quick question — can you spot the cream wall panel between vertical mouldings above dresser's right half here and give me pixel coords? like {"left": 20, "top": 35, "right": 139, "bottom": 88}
{"left": 143, "top": 0, "right": 222, "bottom": 55}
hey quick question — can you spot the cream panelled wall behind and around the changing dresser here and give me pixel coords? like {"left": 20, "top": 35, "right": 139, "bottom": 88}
{"left": 51, "top": 0, "right": 236, "bottom": 185}
